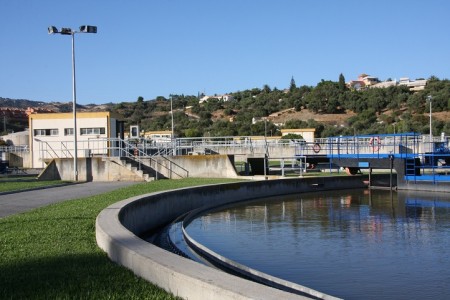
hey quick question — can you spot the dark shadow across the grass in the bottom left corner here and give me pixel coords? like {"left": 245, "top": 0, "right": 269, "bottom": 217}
{"left": 0, "top": 251, "right": 174, "bottom": 299}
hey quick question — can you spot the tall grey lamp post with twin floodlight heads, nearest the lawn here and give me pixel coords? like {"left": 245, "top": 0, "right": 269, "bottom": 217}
{"left": 48, "top": 25, "right": 97, "bottom": 181}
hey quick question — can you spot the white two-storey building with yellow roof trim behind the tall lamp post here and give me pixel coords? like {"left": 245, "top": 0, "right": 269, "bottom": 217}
{"left": 28, "top": 112, "right": 123, "bottom": 168}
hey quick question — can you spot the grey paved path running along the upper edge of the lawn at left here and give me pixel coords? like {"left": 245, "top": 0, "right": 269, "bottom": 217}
{"left": 0, "top": 181, "right": 139, "bottom": 218}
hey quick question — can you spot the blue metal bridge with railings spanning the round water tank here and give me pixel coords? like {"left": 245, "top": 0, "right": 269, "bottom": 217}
{"left": 296, "top": 132, "right": 450, "bottom": 183}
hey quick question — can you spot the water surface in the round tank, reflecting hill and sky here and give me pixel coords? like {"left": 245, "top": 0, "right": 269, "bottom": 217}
{"left": 187, "top": 190, "right": 450, "bottom": 299}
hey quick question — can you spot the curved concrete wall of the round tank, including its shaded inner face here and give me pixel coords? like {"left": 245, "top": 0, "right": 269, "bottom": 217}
{"left": 96, "top": 176, "right": 376, "bottom": 299}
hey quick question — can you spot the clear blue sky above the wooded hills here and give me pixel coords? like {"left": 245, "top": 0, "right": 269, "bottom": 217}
{"left": 0, "top": 0, "right": 450, "bottom": 104}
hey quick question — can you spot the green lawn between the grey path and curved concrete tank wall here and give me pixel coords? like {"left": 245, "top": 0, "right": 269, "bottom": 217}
{"left": 0, "top": 178, "right": 243, "bottom": 299}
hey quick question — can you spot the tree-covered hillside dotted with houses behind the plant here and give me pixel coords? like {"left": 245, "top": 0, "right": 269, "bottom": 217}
{"left": 0, "top": 77, "right": 450, "bottom": 137}
